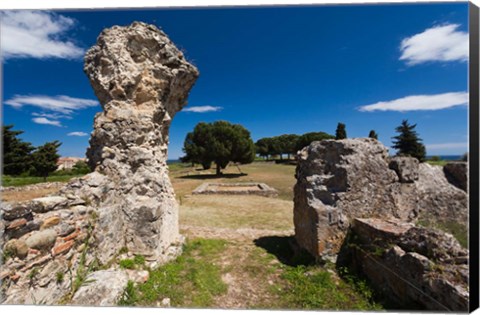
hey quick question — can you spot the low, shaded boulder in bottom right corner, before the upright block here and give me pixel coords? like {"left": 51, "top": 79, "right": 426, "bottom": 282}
{"left": 342, "top": 219, "right": 469, "bottom": 312}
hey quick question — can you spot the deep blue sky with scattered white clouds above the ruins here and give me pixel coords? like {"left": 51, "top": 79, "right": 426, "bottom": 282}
{"left": 0, "top": 2, "right": 468, "bottom": 159}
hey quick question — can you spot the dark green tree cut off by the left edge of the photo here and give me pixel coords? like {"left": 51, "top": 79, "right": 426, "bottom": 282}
{"left": 2, "top": 125, "right": 34, "bottom": 175}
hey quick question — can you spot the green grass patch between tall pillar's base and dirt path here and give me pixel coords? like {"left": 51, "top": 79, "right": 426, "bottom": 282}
{"left": 119, "top": 239, "right": 227, "bottom": 307}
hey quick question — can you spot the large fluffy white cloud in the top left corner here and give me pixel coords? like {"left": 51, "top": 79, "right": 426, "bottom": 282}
{"left": 0, "top": 11, "right": 84, "bottom": 59}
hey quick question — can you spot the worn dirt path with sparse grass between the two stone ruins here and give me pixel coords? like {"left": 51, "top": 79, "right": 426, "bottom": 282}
{"left": 181, "top": 226, "right": 293, "bottom": 309}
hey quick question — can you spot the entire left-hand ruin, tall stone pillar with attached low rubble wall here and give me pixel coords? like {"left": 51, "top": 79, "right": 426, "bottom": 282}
{"left": 0, "top": 22, "right": 199, "bottom": 305}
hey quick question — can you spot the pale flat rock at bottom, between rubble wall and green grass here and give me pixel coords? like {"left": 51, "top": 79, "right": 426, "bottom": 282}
{"left": 72, "top": 270, "right": 128, "bottom": 306}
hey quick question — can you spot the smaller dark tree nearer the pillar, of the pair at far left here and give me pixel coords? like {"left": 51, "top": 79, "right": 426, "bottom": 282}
{"left": 32, "top": 141, "right": 61, "bottom": 181}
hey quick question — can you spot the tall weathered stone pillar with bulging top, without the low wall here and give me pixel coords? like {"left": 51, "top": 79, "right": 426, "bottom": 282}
{"left": 69, "top": 22, "right": 198, "bottom": 262}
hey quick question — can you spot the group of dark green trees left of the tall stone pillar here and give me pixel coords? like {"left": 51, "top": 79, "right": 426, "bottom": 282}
{"left": 2, "top": 125, "right": 89, "bottom": 181}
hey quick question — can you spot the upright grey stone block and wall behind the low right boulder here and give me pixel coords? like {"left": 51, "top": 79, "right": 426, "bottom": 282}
{"left": 294, "top": 138, "right": 468, "bottom": 259}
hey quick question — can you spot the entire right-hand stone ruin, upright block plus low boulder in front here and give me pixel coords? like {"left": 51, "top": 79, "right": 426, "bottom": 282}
{"left": 294, "top": 139, "right": 469, "bottom": 311}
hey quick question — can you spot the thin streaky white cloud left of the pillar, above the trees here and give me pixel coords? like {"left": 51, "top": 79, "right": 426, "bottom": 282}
{"left": 5, "top": 95, "right": 98, "bottom": 118}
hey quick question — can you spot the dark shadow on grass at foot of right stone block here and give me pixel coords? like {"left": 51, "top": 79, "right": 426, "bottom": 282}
{"left": 253, "top": 236, "right": 315, "bottom": 267}
